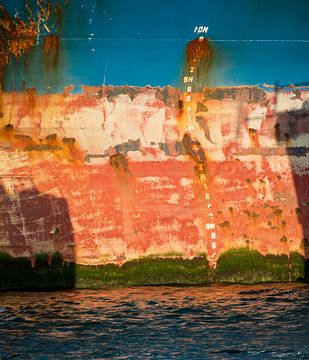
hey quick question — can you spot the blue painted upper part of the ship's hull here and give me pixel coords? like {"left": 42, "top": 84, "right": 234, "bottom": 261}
{"left": 2, "top": 0, "right": 309, "bottom": 92}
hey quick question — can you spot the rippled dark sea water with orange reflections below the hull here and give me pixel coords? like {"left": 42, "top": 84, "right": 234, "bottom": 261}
{"left": 0, "top": 284, "right": 309, "bottom": 359}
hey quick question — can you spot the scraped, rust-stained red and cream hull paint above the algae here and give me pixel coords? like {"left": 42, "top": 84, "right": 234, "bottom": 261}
{"left": 0, "top": 0, "right": 309, "bottom": 272}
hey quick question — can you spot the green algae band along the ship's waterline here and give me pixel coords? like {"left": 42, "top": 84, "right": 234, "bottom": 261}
{"left": 0, "top": 248, "right": 308, "bottom": 290}
